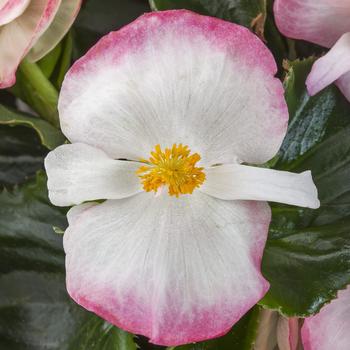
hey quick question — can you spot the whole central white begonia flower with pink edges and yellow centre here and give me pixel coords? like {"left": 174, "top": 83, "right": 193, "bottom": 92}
{"left": 45, "top": 10, "right": 319, "bottom": 345}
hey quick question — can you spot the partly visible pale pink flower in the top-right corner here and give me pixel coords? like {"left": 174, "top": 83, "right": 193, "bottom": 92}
{"left": 274, "top": 0, "right": 350, "bottom": 101}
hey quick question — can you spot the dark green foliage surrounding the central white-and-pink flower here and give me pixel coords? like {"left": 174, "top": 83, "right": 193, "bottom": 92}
{"left": 0, "top": 0, "right": 350, "bottom": 350}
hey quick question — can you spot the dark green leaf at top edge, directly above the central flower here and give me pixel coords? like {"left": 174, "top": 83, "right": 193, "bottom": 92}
{"left": 150, "top": 0, "right": 266, "bottom": 28}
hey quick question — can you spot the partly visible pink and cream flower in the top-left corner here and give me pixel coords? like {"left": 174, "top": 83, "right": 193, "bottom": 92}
{"left": 0, "top": 0, "right": 81, "bottom": 88}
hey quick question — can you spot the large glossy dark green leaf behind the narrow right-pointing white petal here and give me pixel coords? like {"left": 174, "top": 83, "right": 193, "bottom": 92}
{"left": 261, "top": 59, "right": 350, "bottom": 316}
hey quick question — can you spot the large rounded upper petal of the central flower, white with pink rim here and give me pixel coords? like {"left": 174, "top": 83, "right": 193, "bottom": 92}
{"left": 59, "top": 10, "right": 288, "bottom": 164}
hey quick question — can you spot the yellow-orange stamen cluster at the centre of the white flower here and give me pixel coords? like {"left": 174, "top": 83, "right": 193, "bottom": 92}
{"left": 137, "top": 143, "right": 205, "bottom": 197}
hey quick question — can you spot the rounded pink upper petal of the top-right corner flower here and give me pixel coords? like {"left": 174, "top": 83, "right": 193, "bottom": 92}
{"left": 274, "top": 0, "right": 350, "bottom": 47}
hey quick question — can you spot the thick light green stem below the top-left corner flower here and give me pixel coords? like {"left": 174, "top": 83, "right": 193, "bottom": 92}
{"left": 10, "top": 59, "right": 59, "bottom": 128}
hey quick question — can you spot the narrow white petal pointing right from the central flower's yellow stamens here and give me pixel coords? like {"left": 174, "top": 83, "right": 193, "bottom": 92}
{"left": 200, "top": 164, "right": 320, "bottom": 208}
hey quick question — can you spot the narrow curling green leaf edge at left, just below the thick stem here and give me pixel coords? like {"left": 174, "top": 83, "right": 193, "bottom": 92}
{"left": 0, "top": 104, "right": 65, "bottom": 150}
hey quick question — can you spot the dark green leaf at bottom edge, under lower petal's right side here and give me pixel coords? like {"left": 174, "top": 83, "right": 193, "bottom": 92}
{"left": 168, "top": 306, "right": 260, "bottom": 350}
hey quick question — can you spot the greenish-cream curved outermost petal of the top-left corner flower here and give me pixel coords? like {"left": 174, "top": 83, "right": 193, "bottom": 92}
{"left": 27, "top": 0, "right": 82, "bottom": 62}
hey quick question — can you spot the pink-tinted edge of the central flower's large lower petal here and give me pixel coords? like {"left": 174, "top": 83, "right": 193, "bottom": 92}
{"left": 65, "top": 201, "right": 271, "bottom": 346}
